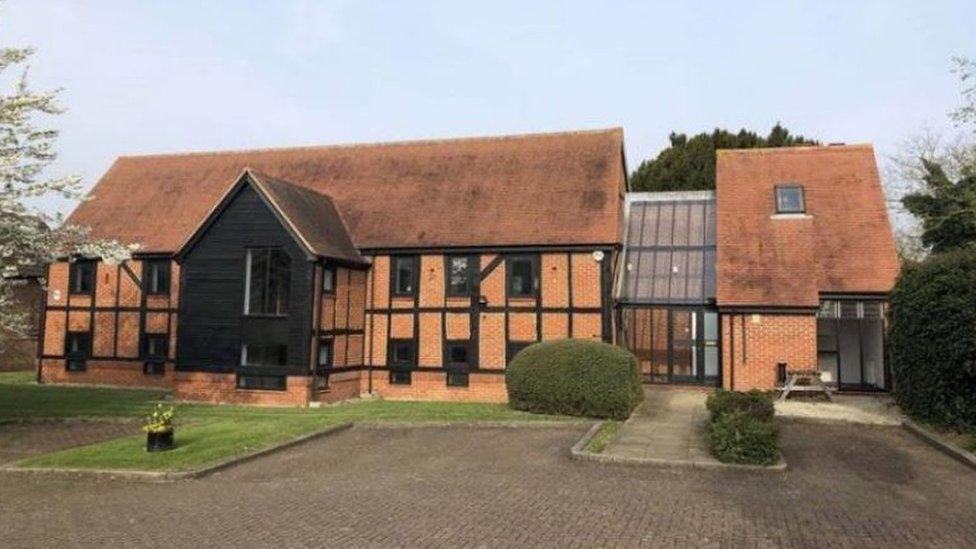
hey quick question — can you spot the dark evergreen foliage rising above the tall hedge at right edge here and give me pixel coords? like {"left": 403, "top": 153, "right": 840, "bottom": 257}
{"left": 902, "top": 159, "right": 976, "bottom": 253}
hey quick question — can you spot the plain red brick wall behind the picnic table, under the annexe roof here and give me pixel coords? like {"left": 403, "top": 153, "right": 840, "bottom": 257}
{"left": 722, "top": 313, "right": 817, "bottom": 391}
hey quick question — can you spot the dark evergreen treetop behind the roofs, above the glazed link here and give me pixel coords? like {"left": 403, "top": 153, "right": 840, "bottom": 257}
{"left": 630, "top": 123, "right": 819, "bottom": 191}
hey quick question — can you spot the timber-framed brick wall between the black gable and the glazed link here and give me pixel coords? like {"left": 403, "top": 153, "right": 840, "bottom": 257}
{"left": 361, "top": 252, "right": 609, "bottom": 402}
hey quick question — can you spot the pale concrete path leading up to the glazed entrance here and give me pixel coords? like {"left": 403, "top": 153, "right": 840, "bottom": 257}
{"left": 603, "top": 386, "right": 719, "bottom": 465}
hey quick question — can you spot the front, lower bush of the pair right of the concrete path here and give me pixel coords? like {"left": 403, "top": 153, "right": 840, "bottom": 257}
{"left": 706, "top": 412, "right": 779, "bottom": 465}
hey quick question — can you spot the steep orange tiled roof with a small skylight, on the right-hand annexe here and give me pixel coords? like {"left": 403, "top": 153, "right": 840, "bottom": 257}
{"left": 716, "top": 145, "right": 899, "bottom": 307}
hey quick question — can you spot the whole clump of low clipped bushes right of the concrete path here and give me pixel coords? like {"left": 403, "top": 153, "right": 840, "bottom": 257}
{"left": 705, "top": 390, "right": 779, "bottom": 465}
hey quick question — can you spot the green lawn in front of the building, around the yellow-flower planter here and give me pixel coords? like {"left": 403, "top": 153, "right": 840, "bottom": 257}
{"left": 0, "top": 372, "right": 566, "bottom": 471}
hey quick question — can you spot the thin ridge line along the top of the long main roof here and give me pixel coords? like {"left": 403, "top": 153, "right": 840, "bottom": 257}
{"left": 118, "top": 126, "right": 623, "bottom": 159}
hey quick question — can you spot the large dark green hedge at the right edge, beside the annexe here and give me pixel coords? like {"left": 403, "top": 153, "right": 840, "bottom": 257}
{"left": 890, "top": 248, "right": 976, "bottom": 430}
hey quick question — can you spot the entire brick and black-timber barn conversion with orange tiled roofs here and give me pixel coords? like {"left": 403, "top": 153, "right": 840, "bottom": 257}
{"left": 38, "top": 128, "right": 898, "bottom": 405}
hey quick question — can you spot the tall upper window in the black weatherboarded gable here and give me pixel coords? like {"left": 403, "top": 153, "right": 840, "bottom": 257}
{"left": 244, "top": 248, "right": 291, "bottom": 316}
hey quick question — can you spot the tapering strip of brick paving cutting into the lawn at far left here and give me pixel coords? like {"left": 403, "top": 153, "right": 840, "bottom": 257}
{"left": 0, "top": 420, "right": 139, "bottom": 464}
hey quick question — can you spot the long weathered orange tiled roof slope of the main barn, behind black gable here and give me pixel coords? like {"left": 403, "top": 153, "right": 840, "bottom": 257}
{"left": 69, "top": 128, "right": 624, "bottom": 252}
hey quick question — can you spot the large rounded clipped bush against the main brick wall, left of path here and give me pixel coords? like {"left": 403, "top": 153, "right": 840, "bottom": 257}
{"left": 505, "top": 339, "right": 644, "bottom": 420}
